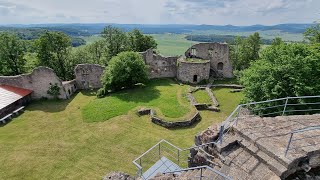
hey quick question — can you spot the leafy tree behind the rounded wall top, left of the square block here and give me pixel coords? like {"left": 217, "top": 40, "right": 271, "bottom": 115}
{"left": 36, "top": 32, "right": 73, "bottom": 80}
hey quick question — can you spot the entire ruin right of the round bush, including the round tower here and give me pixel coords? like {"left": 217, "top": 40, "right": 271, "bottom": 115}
{"left": 140, "top": 43, "right": 233, "bottom": 84}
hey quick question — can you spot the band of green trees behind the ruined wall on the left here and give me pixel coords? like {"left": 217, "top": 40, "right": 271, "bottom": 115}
{"left": 0, "top": 26, "right": 157, "bottom": 80}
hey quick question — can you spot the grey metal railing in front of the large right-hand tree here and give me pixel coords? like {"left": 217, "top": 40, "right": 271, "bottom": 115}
{"left": 217, "top": 96, "right": 320, "bottom": 143}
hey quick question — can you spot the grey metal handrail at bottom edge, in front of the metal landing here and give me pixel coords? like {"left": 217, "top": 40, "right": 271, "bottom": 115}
{"left": 167, "top": 166, "right": 232, "bottom": 180}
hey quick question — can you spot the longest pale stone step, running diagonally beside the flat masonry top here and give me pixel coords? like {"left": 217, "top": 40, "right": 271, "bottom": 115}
{"left": 239, "top": 139, "right": 288, "bottom": 176}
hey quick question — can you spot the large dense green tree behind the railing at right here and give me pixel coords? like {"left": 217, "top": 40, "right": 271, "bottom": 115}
{"left": 240, "top": 43, "right": 320, "bottom": 102}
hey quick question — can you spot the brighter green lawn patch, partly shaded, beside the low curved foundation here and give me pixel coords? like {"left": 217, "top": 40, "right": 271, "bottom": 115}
{"left": 82, "top": 79, "right": 192, "bottom": 122}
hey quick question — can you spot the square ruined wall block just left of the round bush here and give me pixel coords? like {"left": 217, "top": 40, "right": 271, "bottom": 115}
{"left": 74, "top": 64, "right": 105, "bottom": 89}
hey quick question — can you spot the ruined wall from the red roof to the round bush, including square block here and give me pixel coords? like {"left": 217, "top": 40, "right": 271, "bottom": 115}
{"left": 0, "top": 64, "right": 104, "bottom": 99}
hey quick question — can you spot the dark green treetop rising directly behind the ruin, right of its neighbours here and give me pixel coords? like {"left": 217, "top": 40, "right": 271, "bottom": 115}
{"left": 128, "top": 29, "right": 157, "bottom": 52}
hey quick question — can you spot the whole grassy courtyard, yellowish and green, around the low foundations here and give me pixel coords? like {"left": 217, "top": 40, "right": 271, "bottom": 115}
{"left": 0, "top": 80, "right": 242, "bottom": 179}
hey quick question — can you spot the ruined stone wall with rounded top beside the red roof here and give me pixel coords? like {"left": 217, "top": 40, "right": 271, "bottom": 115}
{"left": 0, "top": 67, "right": 67, "bottom": 99}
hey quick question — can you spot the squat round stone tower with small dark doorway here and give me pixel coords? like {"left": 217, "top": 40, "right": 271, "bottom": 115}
{"left": 177, "top": 58, "right": 210, "bottom": 84}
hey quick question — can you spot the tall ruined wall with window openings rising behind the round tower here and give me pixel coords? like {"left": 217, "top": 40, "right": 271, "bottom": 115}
{"left": 185, "top": 43, "right": 233, "bottom": 78}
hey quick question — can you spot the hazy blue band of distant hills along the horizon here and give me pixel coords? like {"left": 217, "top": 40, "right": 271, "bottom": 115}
{"left": 0, "top": 23, "right": 312, "bottom": 36}
